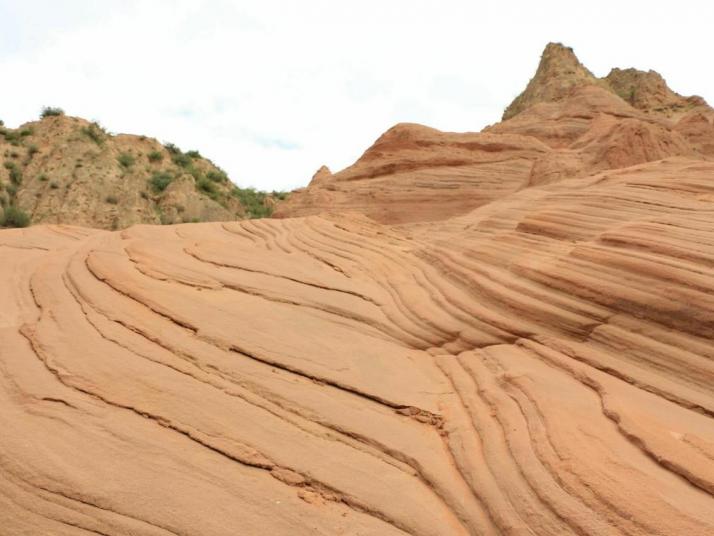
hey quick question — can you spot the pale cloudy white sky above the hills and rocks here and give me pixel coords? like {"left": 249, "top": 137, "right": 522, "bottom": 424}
{"left": 0, "top": 0, "right": 714, "bottom": 190}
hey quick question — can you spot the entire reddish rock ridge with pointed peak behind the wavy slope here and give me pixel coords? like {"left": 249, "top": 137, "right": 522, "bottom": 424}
{"left": 275, "top": 43, "right": 714, "bottom": 224}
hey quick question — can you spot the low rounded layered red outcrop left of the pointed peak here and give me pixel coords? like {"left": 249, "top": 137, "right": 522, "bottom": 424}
{"left": 274, "top": 124, "right": 549, "bottom": 223}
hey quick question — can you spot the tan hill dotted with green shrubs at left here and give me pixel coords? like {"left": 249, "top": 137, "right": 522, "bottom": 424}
{"left": 0, "top": 108, "right": 282, "bottom": 229}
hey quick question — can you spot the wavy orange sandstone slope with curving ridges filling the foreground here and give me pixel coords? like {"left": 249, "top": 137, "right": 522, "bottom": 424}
{"left": 0, "top": 158, "right": 714, "bottom": 536}
